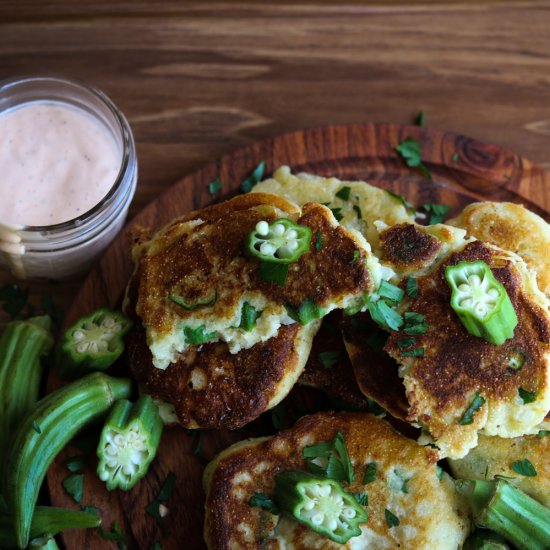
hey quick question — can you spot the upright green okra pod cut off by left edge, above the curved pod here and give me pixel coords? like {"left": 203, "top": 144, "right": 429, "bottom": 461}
{"left": 0, "top": 315, "right": 53, "bottom": 469}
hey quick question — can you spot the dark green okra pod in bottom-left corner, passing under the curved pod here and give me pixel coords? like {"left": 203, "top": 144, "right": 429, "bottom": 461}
{"left": 0, "top": 506, "right": 101, "bottom": 550}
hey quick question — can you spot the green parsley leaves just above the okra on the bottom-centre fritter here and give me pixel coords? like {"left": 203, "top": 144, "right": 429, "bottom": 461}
{"left": 302, "top": 432, "right": 355, "bottom": 483}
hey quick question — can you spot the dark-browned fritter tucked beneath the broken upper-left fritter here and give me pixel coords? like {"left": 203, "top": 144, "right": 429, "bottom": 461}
{"left": 128, "top": 323, "right": 304, "bottom": 430}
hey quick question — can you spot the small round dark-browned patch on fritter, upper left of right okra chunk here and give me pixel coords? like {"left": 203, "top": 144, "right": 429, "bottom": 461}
{"left": 380, "top": 223, "right": 441, "bottom": 271}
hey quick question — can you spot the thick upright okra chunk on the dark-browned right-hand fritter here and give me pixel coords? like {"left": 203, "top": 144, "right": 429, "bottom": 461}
{"left": 445, "top": 260, "right": 518, "bottom": 346}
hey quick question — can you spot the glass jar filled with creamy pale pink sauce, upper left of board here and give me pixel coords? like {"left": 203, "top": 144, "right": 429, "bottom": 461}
{"left": 0, "top": 76, "right": 137, "bottom": 280}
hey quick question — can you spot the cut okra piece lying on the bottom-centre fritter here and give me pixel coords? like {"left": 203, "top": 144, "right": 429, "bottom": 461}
{"left": 275, "top": 470, "right": 368, "bottom": 544}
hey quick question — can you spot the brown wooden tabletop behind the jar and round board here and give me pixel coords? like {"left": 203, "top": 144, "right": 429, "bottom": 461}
{"left": 0, "top": 0, "right": 550, "bottom": 548}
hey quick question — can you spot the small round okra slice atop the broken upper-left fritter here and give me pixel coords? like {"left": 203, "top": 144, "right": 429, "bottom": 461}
{"left": 247, "top": 218, "right": 311, "bottom": 264}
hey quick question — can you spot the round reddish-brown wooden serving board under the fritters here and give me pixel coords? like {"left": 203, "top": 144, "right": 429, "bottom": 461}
{"left": 47, "top": 124, "right": 550, "bottom": 550}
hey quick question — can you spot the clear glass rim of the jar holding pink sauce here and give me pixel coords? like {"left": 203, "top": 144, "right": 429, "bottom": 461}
{"left": 0, "top": 74, "right": 135, "bottom": 234}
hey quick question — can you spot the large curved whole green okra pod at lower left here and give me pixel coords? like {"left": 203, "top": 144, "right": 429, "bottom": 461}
{"left": 2, "top": 373, "right": 132, "bottom": 548}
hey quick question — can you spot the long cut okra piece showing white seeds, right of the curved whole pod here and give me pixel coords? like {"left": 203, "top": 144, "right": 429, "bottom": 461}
{"left": 97, "top": 395, "right": 163, "bottom": 491}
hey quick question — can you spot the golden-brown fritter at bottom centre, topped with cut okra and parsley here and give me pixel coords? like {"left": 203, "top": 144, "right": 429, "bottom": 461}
{"left": 204, "top": 413, "right": 469, "bottom": 550}
